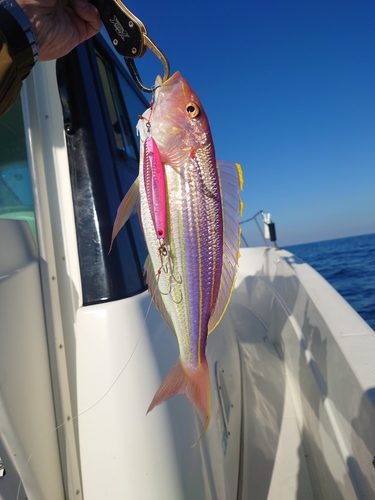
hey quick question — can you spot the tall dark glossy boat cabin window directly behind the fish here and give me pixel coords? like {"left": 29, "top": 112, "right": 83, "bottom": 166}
{"left": 57, "top": 35, "right": 147, "bottom": 305}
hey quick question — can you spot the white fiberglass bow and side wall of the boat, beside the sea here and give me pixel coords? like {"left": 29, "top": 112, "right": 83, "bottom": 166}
{"left": 236, "top": 249, "right": 375, "bottom": 500}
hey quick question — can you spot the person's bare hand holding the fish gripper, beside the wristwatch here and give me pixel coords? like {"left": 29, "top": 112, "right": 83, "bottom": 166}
{"left": 16, "top": 0, "right": 102, "bottom": 61}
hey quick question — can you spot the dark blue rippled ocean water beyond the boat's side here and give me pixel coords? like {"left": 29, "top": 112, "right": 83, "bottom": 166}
{"left": 286, "top": 234, "right": 375, "bottom": 330}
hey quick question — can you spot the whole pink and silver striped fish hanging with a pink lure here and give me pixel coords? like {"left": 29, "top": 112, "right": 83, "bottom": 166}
{"left": 111, "top": 72, "right": 243, "bottom": 436}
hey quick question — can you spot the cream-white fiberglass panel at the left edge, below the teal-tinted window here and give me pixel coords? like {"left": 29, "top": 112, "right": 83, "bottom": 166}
{"left": 0, "top": 220, "right": 64, "bottom": 500}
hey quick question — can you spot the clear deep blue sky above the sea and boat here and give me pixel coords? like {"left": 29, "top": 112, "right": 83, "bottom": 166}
{"left": 125, "top": 0, "right": 375, "bottom": 246}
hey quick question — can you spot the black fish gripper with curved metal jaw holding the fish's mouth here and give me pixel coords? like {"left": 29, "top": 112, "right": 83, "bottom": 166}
{"left": 91, "top": 0, "right": 170, "bottom": 92}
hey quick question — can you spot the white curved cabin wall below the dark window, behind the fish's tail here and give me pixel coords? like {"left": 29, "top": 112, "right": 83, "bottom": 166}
{"left": 76, "top": 292, "right": 241, "bottom": 500}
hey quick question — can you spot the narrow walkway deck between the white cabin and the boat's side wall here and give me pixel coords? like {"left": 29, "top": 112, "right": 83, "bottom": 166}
{"left": 234, "top": 300, "right": 314, "bottom": 500}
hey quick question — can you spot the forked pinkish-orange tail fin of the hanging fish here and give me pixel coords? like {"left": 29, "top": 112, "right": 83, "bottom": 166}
{"left": 147, "top": 358, "right": 211, "bottom": 442}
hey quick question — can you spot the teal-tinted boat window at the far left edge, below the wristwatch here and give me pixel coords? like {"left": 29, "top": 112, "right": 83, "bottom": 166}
{"left": 0, "top": 98, "right": 37, "bottom": 241}
